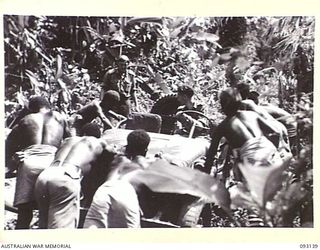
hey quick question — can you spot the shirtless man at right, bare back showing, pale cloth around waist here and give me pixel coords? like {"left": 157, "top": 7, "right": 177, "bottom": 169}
{"left": 204, "top": 88, "right": 281, "bottom": 176}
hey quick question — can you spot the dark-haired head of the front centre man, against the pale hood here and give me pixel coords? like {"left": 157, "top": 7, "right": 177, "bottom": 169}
{"left": 126, "top": 129, "right": 150, "bottom": 157}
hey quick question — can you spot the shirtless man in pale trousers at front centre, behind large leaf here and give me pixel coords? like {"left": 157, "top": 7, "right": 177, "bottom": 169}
{"left": 84, "top": 130, "right": 150, "bottom": 228}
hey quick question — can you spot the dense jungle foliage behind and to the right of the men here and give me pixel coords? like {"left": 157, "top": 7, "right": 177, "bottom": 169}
{"left": 4, "top": 15, "right": 315, "bottom": 227}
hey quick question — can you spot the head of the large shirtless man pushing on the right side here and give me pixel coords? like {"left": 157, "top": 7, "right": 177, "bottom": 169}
{"left": 220, "top": 88, "right": 242, "bottom": 116}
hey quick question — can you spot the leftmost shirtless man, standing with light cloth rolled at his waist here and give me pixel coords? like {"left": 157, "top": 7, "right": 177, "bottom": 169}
{"left": 6, "top": 96, "right": 70, "bottom": 229}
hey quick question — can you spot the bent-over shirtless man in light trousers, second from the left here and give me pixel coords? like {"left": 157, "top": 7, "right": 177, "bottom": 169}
{"left": 35, "top": 136, "right": 112, "bottom": 228}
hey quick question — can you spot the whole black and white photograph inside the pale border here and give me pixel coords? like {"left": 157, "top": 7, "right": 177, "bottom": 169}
{"left": 2, "top": 14, "right": 315, "bottom": 230}
